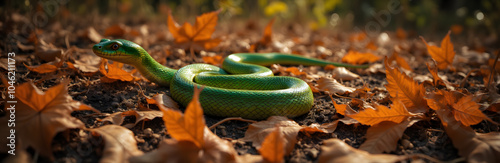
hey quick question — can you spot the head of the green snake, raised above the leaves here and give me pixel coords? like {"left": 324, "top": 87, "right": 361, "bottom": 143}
{"left": 92, "top": 39, "right": 147, "bottom": 65}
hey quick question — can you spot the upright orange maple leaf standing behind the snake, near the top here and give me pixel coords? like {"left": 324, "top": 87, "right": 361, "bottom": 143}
{"left": 167, "top": 10, "right": 221, "bottom": 49}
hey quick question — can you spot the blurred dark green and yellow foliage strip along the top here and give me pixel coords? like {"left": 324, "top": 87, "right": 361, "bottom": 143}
{"left": 0, "top": 0, "right": 500, "bottom": 35}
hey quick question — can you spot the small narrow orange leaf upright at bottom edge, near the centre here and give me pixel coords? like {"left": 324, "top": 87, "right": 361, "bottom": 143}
{"left": 259, "top": 126, "right": 285, "bottom": 163}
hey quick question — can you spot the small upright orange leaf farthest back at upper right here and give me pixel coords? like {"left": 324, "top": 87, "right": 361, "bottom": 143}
{"left": 420, "top": 32, "right": 455, "bottom": 69}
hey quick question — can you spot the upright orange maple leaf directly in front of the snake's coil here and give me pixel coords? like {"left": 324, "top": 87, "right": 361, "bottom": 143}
{"left": 159, "top": 86, "right": 205, "bottom": 148}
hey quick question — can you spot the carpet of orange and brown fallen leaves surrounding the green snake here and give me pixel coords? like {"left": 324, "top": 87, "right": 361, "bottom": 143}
{"left": 0, "top": 8, "right": 499, "bottom": 162}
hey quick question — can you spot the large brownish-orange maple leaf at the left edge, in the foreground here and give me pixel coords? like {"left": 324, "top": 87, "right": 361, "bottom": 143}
{"left": 1, "top": 80, "right": 90, "bottom": 158}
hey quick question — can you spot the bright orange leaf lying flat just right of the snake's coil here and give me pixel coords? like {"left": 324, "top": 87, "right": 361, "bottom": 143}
{"left": 347, "top": 99, "right": 412, "bottom": 126}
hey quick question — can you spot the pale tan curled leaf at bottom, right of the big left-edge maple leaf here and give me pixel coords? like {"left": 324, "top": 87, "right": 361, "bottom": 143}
{"left": 88, "top": 125, "right": 143, "bottom": 162}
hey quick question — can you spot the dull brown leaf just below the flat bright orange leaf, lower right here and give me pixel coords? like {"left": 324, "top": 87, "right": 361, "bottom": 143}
{"left": 359, "top": 119, "right": 418, "bottom": 154}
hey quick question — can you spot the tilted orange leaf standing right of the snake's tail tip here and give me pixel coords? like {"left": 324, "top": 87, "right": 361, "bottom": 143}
{"left": 384, "top": 58, "right": 427, "bottom": 113}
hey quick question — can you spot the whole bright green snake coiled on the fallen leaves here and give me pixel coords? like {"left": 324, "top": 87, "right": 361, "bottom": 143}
{"left": 92, "top": 39, "right": 367, "bottom": 119}
